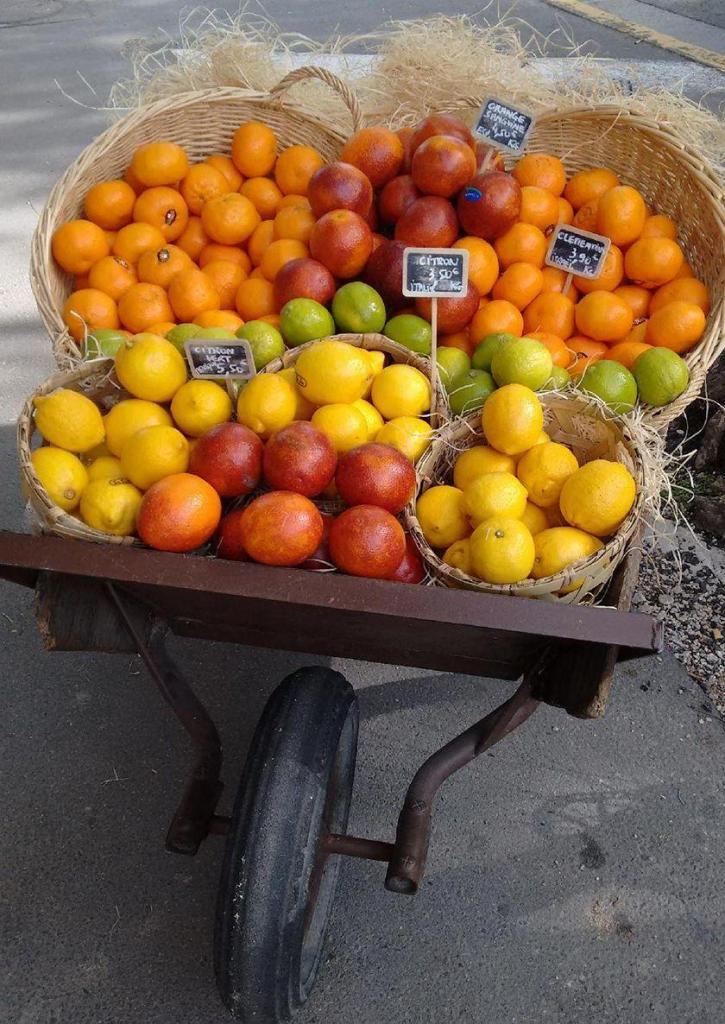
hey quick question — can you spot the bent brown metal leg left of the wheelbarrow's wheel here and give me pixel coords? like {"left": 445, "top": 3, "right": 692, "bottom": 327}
{"left": 105, "top": 583, "right": 226, "bottom": 855}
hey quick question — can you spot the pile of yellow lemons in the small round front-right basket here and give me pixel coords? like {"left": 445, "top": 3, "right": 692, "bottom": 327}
{"left": 416, "top": 384, "right": 637, "bottom": 593}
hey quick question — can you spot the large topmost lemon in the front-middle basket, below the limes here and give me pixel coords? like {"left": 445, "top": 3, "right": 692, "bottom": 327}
{"left": 295, "top": 341, "right": 373, "bottom": 406}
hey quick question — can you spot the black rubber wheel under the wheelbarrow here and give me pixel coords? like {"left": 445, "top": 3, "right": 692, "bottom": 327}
{"left": 214, "top": 668, "right": 358, "bottom": 1024}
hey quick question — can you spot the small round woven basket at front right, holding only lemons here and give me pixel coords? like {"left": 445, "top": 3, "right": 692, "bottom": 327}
{"left": 406, "top": 392, "right": 645, "bottom": 604}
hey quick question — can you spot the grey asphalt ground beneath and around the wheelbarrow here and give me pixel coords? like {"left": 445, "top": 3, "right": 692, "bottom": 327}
{"left": 0, "top": 0, "right": 725, "bottom": 1024}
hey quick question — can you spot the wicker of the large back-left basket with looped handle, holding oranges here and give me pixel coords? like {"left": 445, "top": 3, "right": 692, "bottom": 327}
{"left": 30, "top": 67, "right": 363, "bottom": 369}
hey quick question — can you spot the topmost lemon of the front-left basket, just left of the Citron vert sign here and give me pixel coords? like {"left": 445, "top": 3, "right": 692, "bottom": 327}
{"left": 116, "top": 334, "right": 186, "bottom": 401}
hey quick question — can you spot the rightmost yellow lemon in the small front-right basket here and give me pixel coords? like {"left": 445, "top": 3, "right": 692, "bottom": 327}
{"left": 559, "top": 459, "right": 637, "bottom": 537}
